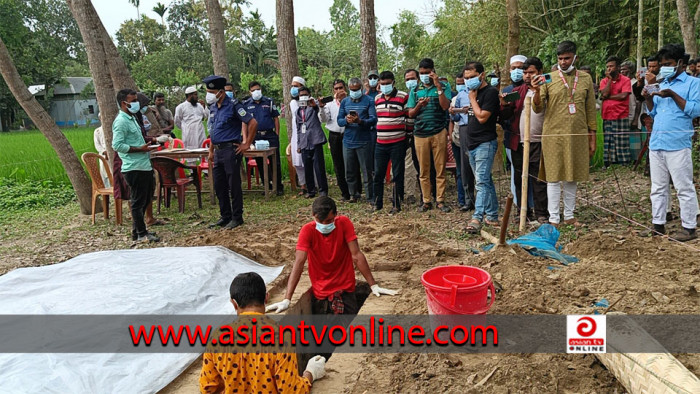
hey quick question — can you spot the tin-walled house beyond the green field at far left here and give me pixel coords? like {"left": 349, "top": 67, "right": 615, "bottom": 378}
{"left": 29, "top": 77, "right": 100, "bottom": 127}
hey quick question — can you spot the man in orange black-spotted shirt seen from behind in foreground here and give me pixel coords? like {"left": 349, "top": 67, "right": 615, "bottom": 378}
{"left": 199, "top": 272, "right": 326, "bottom": 394}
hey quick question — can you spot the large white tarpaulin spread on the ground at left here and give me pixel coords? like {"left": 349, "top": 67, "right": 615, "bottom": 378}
{"left": 0, "top": 246, "right": 282, "bottom": 393}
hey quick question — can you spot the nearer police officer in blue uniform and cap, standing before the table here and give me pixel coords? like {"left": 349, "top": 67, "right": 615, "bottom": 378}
{"left": 202, "top": 75, "right": 258, "bottom": 229}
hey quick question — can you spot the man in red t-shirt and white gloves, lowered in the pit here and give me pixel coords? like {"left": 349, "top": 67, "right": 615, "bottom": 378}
{"left": 266, "top": 196, "right": 397, "bottom": 315}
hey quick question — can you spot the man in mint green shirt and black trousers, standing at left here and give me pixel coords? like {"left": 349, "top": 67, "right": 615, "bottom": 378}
{"left": 112, "top": 89, "right": 160, "bottom": 242}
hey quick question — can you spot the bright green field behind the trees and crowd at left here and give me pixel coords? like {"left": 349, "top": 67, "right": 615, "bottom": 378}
{"left": 0, "top": 119, "right": 334, "bottom": 184}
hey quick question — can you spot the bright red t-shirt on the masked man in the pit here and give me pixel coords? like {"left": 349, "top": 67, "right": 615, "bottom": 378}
{"left": 297, "top": 215, "right": 357, "bottom": 300}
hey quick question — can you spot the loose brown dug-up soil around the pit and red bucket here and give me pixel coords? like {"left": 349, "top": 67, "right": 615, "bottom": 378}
{"left": 0, "top": 166, "right": 700, "bottom": 393}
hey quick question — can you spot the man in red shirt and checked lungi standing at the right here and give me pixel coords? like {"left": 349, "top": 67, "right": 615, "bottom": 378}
{"left": 600, "top": 56, "right": 632, "bottom": 167}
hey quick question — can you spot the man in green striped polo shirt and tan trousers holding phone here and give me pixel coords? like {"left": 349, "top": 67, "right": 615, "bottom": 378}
{"left": 406, "top": 58, "right": 452, "bottom": 212}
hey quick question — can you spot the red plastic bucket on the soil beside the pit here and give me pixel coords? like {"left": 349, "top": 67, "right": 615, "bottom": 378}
{"left": 421, "top": 265, "right": 496, "bottom": 315}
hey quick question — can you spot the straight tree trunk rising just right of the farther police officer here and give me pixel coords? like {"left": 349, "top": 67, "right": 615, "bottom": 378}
{"left": 276, "top": 0, "right": 300, "bottom": 140}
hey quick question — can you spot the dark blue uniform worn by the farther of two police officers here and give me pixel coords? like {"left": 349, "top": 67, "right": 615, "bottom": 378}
{"left": 243, "top": 97, "right": 284, "bottom": 194}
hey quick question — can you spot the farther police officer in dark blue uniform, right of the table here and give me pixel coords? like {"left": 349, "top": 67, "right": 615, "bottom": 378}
{"left": 243, "top": 81, "right": 284, "bottom": 196}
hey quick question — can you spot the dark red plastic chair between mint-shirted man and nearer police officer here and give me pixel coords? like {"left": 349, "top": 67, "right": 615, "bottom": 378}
{"left": 151, "top": 157, "right": 202, "bottom": 213}
